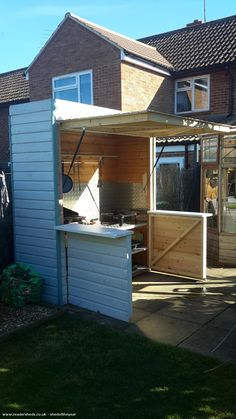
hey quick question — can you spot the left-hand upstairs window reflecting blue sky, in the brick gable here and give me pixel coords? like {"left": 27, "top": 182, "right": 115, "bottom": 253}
{"left": 52, "top": 70, "right": 93, "bottom": 105}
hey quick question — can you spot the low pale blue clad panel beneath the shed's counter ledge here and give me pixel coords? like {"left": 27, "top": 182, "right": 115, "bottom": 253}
{"left": 64, "top": 232, "right": 132, "bottom": 321}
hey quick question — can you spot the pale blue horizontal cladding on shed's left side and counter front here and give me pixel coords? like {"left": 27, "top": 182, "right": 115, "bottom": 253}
{"left": 10, "top": 100, "right": 132, "bottom": 321}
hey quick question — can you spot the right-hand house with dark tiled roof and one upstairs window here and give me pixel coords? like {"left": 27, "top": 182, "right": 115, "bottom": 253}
{"left": 140, "top": 15, "right": 236, "bottom": 124}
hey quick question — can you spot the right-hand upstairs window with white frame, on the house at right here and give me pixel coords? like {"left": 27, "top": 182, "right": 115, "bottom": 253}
{"left": 175, "top": 76, "right": 210, "bottom": 113}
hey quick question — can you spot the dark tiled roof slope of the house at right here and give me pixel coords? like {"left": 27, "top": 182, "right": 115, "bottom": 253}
{"left": 140, "top": 15, "right": 236, "bottom": 71}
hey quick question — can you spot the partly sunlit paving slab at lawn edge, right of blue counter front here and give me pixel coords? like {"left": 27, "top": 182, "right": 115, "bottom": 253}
{"left": 127, "top": 311, "right": 199, "bottom": 345}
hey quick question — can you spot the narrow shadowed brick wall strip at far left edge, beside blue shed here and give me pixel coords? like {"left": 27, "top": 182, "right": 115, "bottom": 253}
{"left": 0, "top": 106, "right": 10, "bottom": 169}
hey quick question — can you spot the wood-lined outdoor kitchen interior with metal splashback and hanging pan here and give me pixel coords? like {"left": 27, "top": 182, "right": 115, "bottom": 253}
{"left": 60, "top": 131, "right": 149, "bottom": 276}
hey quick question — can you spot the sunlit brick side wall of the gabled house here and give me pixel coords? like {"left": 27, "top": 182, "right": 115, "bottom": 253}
{"left": 121, "top": 63, "right": 174, "bottom": 113}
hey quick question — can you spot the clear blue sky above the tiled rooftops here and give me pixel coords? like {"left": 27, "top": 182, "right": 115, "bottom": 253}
{"left": 0, "top": 0, "right": 236, "bottom": 73}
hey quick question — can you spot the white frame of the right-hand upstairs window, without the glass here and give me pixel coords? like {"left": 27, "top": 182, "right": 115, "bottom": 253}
{"left": 175, "top": 74, "right": 210, "bottom": 114}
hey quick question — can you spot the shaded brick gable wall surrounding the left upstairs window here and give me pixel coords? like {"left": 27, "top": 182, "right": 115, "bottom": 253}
{"left": 29, "top": 19, "right": 121, "bottom": 109}
